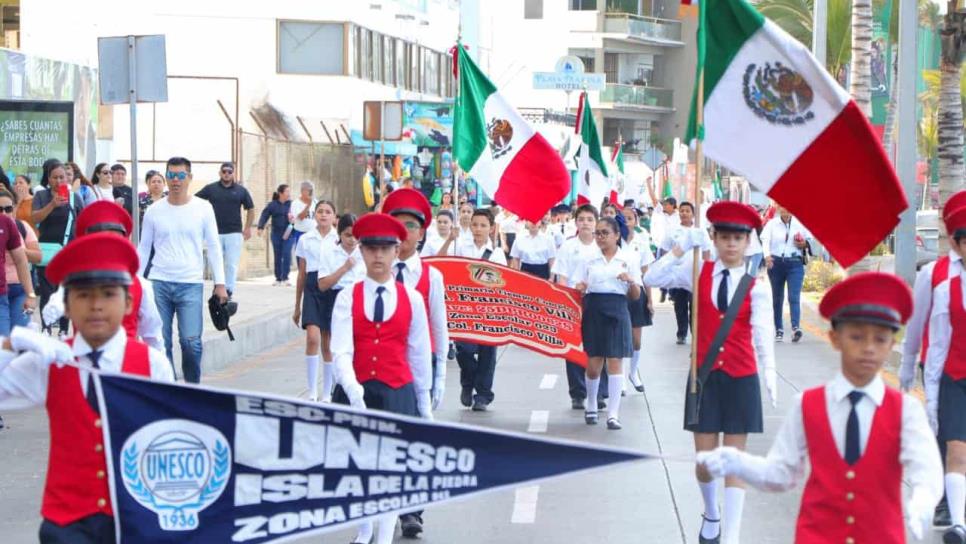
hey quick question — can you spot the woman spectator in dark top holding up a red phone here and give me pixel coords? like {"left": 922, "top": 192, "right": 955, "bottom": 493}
{"left": 30, "top": 159, "right": 84, "bottom": 335}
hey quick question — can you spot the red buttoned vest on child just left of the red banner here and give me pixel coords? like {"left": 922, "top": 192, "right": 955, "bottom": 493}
{"left": 352, "top": 281, "right": 413, "bottom": 389}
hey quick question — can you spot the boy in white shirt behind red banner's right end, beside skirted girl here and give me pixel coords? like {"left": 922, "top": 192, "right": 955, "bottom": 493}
{"left": 550, "top": 204, "right": 607, "bottom": 410}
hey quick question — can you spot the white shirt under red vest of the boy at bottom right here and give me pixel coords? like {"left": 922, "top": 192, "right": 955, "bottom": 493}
{"left": 745, "top": 372, "right": 943, "bottom": 504}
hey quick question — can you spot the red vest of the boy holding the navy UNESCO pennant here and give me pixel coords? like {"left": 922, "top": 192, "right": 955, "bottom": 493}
{"left": 40, "top": 339, "right": 151, "bottom": 526}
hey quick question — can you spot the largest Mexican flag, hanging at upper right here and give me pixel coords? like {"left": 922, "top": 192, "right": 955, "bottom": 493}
{"left": 688, "top": 0, "right": 908, "bottom": 266}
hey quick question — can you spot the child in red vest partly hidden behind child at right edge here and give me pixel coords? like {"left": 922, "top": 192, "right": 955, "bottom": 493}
{"left": 899, "top": 191, "right": 966, "bottom": 526}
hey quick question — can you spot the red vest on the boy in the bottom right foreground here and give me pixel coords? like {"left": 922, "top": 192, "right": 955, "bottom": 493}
{"left": 795, "top": 387, "right": 906, "bottom": 544}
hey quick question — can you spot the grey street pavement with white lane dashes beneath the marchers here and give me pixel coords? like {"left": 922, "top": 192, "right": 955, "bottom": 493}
{"left": 0, "top": 288, "right": 941, "bottom": 544}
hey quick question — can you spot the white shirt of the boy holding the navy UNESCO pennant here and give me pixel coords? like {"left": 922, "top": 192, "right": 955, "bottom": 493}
{"left": 0, "top": 327, "right": 174, "bottom": 410}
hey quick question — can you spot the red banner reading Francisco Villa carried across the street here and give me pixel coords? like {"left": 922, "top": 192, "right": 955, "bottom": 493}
{"left": 426, "top": 257, "right": 587, "bottom": 365}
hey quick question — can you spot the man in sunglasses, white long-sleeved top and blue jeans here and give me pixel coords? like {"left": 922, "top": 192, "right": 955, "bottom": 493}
{"left": 138, "top": 157, "right": 228, "bottom": 383}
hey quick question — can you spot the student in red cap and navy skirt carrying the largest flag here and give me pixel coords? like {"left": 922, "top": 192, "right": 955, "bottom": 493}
{"left": 644, "top": 201, "right": 777, "bottom": 544}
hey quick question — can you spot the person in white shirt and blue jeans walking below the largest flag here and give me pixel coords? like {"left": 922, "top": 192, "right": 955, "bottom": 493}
{"left": 761, "top": 206, "right": 812, "bottom": 342}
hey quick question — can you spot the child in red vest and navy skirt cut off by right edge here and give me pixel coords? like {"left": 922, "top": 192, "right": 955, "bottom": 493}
{"left": 923, "top": 205, "right": 966, "bottom": 544}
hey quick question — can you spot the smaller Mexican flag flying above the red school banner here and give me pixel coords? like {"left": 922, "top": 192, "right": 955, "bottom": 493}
{"left": 453, "top": 43, "right": 570, "bottom": 222}
